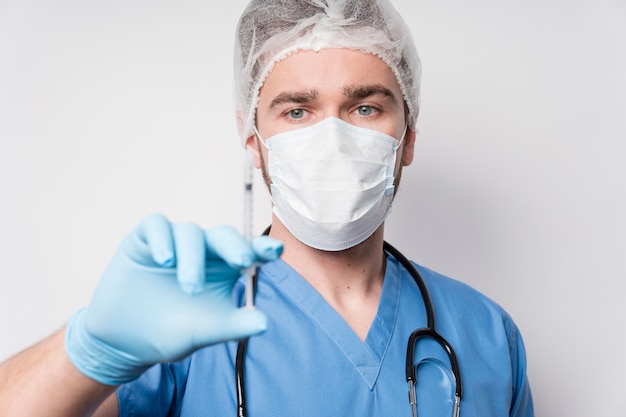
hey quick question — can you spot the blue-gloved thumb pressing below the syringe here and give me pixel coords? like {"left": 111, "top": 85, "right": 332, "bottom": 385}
{"left": 196, "top": 307, "right": 267, "bottom": 346}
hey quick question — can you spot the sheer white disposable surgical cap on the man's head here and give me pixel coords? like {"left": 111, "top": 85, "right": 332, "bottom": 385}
{"left": 234, "top": 0, "right": 421, "bottom": 143}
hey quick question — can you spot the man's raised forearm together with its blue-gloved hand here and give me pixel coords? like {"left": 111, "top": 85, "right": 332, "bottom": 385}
{"left": 0, "top": 215, "right": 282, "bottom": 417}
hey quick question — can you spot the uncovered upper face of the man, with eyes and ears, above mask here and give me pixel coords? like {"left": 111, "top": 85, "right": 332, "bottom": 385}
{"left": 247, "top": 48, "right": 415, "bottom": 185}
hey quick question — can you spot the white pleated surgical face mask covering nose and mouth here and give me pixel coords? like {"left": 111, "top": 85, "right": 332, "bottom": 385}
{"left": 255, "top": 117, "right": 406, "bottom": 251}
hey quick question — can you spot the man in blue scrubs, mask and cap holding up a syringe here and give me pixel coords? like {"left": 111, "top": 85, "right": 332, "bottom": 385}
{"left": 0, "top": 0, "right": 533, "bottom": 417}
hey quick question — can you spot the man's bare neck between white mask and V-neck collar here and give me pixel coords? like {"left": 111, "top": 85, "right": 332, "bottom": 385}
{"left": 270, "top": 217, "right": 385, "bottom": 340}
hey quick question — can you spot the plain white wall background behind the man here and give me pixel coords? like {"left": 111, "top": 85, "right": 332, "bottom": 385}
{"left": 0, "top": 0, "right": 626, "bottom": 417}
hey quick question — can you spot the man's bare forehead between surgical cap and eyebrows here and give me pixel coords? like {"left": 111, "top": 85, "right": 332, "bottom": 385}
{"left": 259, "top": 48, "right": 402, "bottom": 104}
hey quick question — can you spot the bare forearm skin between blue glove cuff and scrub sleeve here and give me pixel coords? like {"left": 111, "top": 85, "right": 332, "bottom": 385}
{"left": 0, "top": 331, "right": 116, "bottom": 417}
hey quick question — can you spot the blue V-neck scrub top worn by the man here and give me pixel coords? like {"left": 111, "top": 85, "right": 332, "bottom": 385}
{"left": 118, "top": 257, "right": 534, "bottom": 417}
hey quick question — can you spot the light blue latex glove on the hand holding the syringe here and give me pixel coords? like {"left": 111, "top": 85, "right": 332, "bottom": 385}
{"left": 65, "top": 214, "right": 282, "bottom": 385}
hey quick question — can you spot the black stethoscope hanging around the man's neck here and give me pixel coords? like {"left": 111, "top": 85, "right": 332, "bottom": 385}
{"left": 235, "top": 237, "right": 463, "bottom": 417}
